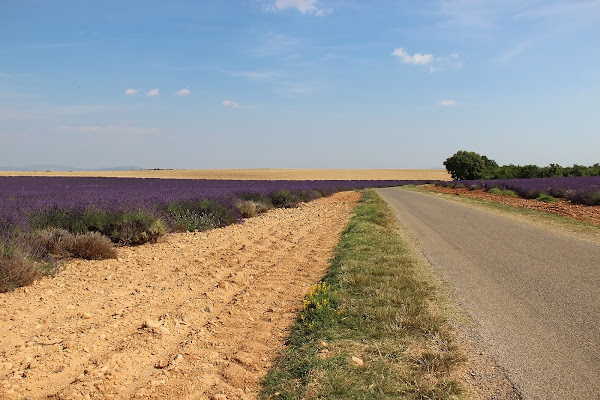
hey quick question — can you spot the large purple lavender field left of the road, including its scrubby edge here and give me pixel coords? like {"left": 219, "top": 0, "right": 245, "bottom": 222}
{"left": 0, "top": 177, "right": 425, "bottom": 292}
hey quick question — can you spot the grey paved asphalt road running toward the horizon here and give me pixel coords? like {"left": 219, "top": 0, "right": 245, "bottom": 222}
{"left": 379, "top": 188, "right": 600, "bottom": 400}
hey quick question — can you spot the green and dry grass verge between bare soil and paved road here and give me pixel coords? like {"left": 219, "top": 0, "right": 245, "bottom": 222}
{"left": 260, "top": 190, "right": 463, "bottom": 399}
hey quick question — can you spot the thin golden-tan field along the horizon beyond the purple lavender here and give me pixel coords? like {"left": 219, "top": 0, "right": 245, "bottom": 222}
{"left": 0, "top": 169, "right": 451, "bottom": 180}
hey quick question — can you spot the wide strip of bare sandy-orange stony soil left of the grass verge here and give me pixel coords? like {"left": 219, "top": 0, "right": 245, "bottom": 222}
{"left": 0, "top": 192, "right": 360, "bottom": 399}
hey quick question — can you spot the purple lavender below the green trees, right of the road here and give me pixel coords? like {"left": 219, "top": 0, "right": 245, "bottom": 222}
{"left": 442, "top": 176, "right": 600, "bottom": 206}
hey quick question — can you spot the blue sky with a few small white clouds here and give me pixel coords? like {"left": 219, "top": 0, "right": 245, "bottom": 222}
{"left": 0, "top": 0, "right": 600, "bottom": 169}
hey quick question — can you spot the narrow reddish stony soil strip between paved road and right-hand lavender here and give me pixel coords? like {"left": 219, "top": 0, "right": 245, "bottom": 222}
{"left": 426, "top": 185, "right": 600, "bottom": 224}
